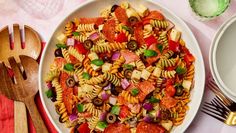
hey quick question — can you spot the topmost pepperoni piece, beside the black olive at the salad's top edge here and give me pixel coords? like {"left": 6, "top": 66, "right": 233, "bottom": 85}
{"left": 115, "top": 7, "right": 128, "bottom": 24}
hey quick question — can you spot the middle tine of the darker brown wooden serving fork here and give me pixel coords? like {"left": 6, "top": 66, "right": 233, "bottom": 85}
{"left": 8, "top": 57, "right": 24, "bottom": 82}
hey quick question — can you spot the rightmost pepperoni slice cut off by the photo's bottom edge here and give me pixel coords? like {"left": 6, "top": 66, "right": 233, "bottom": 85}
{"left": 136, "top": 121, "right": 165, "bottom": 133}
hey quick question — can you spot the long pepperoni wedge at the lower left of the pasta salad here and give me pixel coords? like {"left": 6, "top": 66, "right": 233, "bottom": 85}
{"left": 62, "top": 88, "right": 73, "bottom": 114}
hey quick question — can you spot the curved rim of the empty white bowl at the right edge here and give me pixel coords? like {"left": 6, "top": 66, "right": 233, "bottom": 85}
{"left": 209, "top": 15, "right": 236, "bottom": 102}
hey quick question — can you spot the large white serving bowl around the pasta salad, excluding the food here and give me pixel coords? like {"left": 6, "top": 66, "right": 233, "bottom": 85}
{"left": 39, "top": 0, "right": 205, "bottom": 133}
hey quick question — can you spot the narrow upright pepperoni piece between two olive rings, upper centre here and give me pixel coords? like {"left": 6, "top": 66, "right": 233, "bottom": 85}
{"left": 134, "top": 22, "right": 145, "bottom": 47}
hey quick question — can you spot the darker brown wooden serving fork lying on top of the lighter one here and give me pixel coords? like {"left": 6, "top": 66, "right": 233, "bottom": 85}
{"left": 0, "top": 55, "right": 48, "bottom": 133}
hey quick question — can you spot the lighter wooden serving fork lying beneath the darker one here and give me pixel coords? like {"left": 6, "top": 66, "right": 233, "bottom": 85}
{"left": 0, "top": 24, "right": 41, "bottom": 133}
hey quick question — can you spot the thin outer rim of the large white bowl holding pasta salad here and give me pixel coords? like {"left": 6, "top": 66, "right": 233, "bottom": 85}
{"left": 38, "top": 0, "right": 206, "bottom": 132}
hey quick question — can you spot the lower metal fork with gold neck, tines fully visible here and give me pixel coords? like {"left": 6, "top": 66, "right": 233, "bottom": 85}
{"left": 201, "top": 98, "right": 236, "bottom": 126}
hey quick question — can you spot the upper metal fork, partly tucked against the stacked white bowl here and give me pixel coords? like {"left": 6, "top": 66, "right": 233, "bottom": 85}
{"left": 207, "top": 78, "right": 236, "bottom": 111}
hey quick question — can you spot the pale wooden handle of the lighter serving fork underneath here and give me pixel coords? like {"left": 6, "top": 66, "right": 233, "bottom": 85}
{"left": 14, "top": 101, "right": 28, "bottom": 133}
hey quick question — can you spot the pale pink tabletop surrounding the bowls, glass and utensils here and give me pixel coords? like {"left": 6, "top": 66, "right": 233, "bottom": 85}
{"left": 0, "top": 0, "right": 236, "bottom": 133}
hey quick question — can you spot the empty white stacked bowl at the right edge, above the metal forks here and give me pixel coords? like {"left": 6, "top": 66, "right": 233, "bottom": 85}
{"left": 210, "top": 15, "right": 236, "bottom": 102}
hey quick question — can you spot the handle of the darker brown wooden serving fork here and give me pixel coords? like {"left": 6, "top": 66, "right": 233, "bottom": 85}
{"left": 24, "top": 96, "right": 48, "bottom": 133}
